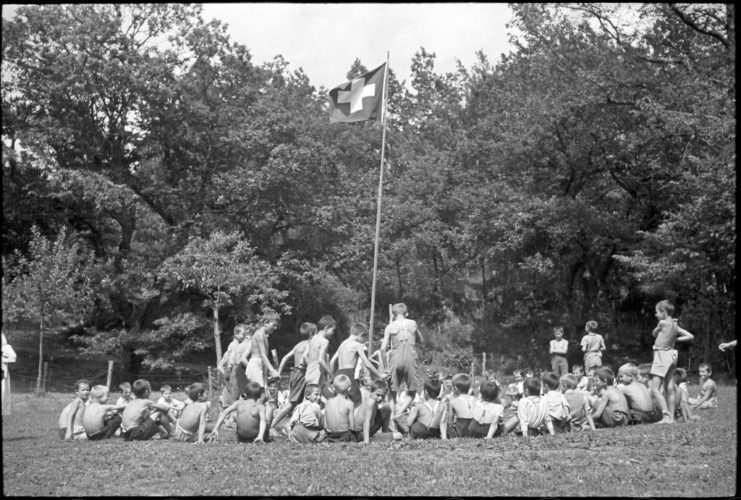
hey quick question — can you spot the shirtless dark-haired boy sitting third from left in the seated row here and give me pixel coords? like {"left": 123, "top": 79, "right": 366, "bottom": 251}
{"left": 121, "top": 379, "right": 178, "bottom": 441}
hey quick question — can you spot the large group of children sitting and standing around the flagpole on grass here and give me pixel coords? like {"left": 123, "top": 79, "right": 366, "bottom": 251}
{"left": 59, "top": 301, "right": 717, "bottom": 443}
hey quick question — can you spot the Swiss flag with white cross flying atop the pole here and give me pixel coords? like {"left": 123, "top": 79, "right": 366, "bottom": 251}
{"left": 329, "top": 63, "right": 386, "bottom": 123}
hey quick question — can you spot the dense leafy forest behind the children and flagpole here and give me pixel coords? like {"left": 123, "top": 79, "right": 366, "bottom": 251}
{"left": 2, "top": 4, "right": 736, "bottom": 386}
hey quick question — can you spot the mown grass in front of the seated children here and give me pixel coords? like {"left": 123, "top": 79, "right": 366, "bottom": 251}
{"left": 2, "top": 386, "right": 737, "bottom": 497}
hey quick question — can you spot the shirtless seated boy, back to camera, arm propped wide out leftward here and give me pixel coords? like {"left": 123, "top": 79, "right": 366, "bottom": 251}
{"left": 208, "top": 382, "right": 267, "bottom": 443}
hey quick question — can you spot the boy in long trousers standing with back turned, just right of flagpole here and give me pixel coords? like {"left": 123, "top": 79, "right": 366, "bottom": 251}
{"left": 381, "top": 303, "right": 422, "bottom": 418}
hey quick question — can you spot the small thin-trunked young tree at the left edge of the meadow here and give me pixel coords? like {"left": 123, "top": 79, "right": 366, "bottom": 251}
{"left": 2, "top": 226, "right": 92, "bottom": 392}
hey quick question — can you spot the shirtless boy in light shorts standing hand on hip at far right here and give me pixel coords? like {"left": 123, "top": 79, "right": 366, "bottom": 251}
{"left": 651, "top": 300, "right": 694, "bottom": 424}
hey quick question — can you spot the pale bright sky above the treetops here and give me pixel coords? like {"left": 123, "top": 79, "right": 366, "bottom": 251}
{"left": 2, "top": 3, "right": 512, "bottom": 89}
